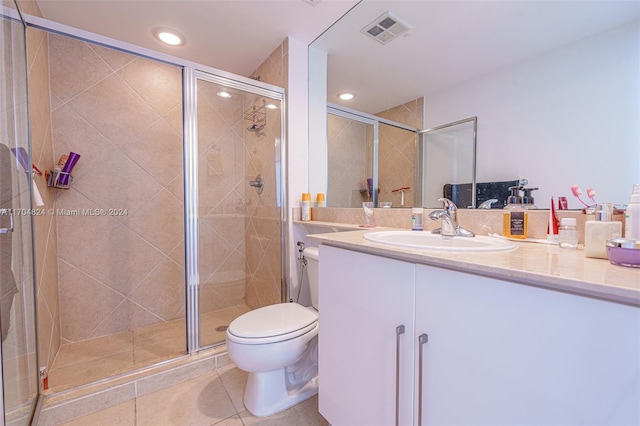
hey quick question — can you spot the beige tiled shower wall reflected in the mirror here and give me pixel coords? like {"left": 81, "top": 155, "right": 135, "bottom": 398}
{"left": 376, "top": 98, "right": 424, "bottom": 207}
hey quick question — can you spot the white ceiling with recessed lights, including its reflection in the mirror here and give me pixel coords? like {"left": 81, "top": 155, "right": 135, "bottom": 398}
{"left": 37, "top": 0, "right": 640, "bottom": 113}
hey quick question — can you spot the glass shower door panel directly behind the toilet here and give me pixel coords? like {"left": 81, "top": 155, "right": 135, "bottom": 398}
{"left": 192, "top": 75, "right": 283, "bottom": 348}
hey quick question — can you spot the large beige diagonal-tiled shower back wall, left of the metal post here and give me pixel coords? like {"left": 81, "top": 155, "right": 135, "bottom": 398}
{"left": 49, "top": 34, "right": 185, "bottom": 343}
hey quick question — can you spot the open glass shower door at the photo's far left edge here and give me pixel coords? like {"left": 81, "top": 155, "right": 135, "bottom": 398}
{"left": 0, "top": 2, "right": 38, "bottom": 425}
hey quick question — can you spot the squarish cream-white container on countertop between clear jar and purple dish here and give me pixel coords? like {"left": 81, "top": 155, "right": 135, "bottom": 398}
{"left": 584, "top": 203, "right": 622, "bottom": 259}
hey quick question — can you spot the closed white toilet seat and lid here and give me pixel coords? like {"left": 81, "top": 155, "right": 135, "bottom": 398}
{"left": 227, "top": 303, "right": 318, "bottom": 345}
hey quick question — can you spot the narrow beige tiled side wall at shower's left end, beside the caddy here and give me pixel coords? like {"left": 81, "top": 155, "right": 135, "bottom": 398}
{"left": 20, "top": 1, "right": 60, "bottom": 378}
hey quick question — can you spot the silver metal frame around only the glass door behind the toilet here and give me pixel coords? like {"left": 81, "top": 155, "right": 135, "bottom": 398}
{"left": 182, "top": 67, "right": 288, "bottom": 354}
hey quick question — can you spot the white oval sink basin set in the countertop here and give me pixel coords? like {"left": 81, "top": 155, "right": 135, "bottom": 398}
{"left": 364, "top": 231, "right": 517, "bottom": 252}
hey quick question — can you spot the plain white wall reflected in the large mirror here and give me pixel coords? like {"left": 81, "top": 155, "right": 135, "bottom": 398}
{"left": 425, "top": 21, "right": 640, "bottom": 208}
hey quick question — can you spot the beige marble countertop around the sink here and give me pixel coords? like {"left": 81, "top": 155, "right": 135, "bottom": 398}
{"left": 307, "top": 226, "right": 640, "bottom": 306}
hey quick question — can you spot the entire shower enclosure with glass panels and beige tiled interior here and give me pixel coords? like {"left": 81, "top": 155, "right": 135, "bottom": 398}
{"left": 0, "top": 4, "right": 286, "bottom": 420}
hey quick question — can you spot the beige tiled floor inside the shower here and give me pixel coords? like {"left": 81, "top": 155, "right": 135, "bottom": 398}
{"left": 49, "top": 305, "right": 250, "bottom": 392}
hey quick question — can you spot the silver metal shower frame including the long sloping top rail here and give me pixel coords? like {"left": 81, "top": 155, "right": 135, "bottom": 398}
{"left": 22, "top": 14, "right": 289, "bottom": 354}
